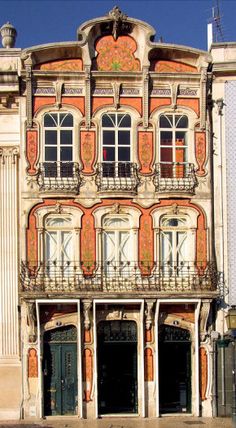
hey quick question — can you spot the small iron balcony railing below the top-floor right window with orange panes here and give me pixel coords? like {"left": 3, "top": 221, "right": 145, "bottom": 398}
{"left": 153, "top": 162, "right": 198, "bottom": 194}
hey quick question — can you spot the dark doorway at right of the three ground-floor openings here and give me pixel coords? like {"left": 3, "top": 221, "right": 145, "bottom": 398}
{"left": 159, "top": 325, "right": 191, "bottom": 413}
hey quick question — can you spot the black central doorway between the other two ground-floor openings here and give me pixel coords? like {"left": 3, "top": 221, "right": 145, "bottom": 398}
{"left": 98, "top": 321, "right": 138, "bottom": 414}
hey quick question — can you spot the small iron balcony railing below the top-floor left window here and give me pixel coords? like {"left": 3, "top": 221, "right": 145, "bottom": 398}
{"left": 38, "top": 162, "right": 82, "bottom": 193}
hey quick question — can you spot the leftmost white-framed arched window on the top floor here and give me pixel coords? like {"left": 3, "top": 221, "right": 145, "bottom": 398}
{"left": 43, "top": 112, "right": 74, "bottom": 177}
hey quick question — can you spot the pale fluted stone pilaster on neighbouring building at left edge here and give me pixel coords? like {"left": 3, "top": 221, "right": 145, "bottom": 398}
{"left": 0, "top": 147, "right": 19, "bottom": 364}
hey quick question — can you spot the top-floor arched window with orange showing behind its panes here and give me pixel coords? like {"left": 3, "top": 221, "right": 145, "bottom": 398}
{"left": 159, "top": 114, "right": 189, "bottom": 178}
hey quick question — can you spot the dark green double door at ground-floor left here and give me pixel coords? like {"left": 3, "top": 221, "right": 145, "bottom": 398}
{"left": 43, "top": 326, "right": 77, "bottom": 416}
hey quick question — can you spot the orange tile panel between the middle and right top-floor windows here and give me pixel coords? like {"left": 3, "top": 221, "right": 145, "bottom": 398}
{"left": 138, "top": 131, "right": 153, "bottom": 174}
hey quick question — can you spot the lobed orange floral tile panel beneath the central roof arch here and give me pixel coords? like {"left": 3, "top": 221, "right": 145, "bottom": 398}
{"left": 96, "top": 35, "right": 140, "bottom": 71}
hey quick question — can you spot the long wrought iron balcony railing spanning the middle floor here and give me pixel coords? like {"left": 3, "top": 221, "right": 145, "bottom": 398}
{"left": 20, "top": 261, "right": 218, "bottom": 293}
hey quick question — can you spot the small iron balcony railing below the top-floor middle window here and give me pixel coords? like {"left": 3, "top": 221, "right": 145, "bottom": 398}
{"left": 96, "top": 162, "right": 139, "bottom": 193}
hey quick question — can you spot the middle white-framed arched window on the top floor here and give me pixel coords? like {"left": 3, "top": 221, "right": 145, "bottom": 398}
{"left": 101, "top": 113, "right": 131, "bottom": 177}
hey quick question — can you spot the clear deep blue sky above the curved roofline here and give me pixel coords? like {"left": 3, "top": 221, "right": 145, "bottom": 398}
{"left": 0, "top": 0, "right": 236, "bottom": 50}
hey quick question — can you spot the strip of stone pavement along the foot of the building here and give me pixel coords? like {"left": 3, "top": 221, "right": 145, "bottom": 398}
{"left": 0, "top": 416, "right": 232, "bottom": 428}
